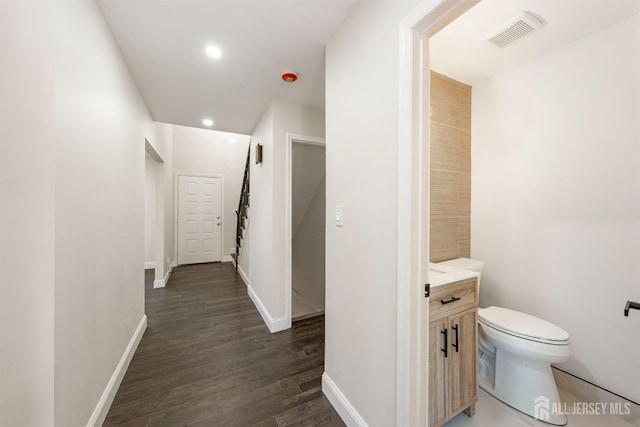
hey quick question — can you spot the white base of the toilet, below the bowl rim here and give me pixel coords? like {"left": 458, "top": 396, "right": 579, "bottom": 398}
{"left": 479, "top": 349, "right": 567, "bottom": 426}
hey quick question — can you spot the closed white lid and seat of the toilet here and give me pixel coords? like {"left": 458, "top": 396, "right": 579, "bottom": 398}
{"left": 478, "top": 307, "right": 569, "bottom": 345}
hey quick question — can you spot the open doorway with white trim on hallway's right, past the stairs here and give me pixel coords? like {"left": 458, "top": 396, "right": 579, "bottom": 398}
{"left": 286, "top": 134, "right": 326, "bottom": 321}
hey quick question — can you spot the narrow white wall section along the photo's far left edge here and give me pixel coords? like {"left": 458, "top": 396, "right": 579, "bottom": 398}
{"left": 0, "top": 1, "right": 56, "bottom": 426}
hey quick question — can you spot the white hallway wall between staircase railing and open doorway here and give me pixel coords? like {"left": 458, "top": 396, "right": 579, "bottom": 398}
{"left": 249, "top": 99, "right": 324, "bottom": 331}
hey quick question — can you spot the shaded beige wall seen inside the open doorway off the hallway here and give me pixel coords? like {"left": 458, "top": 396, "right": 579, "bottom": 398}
{"left": 291, "top": 142, "right": 326, "bottom": 310}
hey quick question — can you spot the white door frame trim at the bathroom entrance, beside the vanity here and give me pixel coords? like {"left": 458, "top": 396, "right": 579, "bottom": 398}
{"left": 396, "top": 0, "right": 480, "bottom": 426}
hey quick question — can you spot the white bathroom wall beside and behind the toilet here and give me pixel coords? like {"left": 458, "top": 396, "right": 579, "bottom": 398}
{"left": 471, "top": 15, "right": 640, "bottom": 402}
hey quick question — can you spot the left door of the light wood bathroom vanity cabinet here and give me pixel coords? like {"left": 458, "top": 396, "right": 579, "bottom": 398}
{"left": 429, "top": 319, "right": 450, "bottom": 426}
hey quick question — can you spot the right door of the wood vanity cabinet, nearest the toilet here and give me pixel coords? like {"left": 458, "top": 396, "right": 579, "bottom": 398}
{"left": 448, "top": 309, "right": 477, "bottom": 415}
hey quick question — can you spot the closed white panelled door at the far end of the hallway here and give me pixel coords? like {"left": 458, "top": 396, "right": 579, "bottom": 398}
{"left": 178, "top": 175, "right": 222, "bottom": 264}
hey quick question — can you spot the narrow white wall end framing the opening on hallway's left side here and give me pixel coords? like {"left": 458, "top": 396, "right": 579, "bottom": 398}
{"left": 144, "top": 139, "right": 168, "bottom": 288}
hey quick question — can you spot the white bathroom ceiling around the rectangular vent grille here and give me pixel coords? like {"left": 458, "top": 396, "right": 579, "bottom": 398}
{"left": 430, "top": 0, "right": 640, "bottom": 85}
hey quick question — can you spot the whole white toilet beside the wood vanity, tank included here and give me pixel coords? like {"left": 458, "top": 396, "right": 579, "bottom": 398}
{"left": 438, "top": 258, "right": 573, "bottom": 425}
